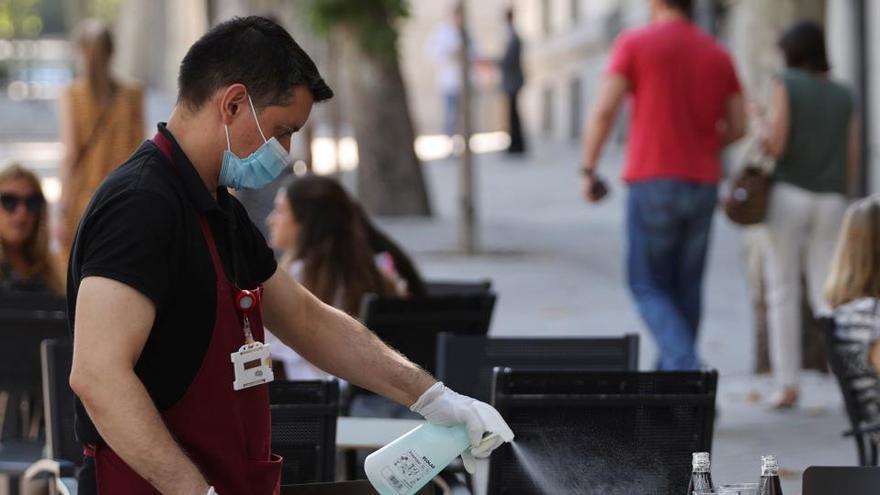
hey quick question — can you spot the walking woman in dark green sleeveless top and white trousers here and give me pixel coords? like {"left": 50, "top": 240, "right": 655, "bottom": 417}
{"left": 763, "top": 21, "right": 859, "bottom": 408}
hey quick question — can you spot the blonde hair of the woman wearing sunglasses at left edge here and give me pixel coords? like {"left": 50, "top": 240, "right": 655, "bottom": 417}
{"left": 0, "top": 163, "right": 64, "bottom": 295}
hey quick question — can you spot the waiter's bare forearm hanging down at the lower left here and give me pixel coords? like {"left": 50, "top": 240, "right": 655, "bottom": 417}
{"left": 72, "top": 370, "right": 208, "bottom": 495}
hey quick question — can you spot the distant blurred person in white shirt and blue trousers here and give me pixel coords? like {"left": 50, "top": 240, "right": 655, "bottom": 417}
{"left": 428, "top": 2, "right": 474, "bottom": 137}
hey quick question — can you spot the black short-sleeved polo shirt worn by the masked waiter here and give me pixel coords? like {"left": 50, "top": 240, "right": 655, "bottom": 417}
{"left": 67, "top": 124, "right": 276, "bottom": 443}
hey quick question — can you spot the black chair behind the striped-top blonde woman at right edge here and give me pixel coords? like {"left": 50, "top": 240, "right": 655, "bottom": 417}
{"left": 820, "top": 318, "right": 880, "bottom": 466}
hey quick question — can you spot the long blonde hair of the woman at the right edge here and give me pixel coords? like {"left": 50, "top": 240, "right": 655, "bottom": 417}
{"left": 825, "top": 196, "right": 880, "bottom": 307}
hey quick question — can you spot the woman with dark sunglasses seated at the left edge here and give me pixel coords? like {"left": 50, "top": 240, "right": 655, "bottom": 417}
{"left": 0, "top": 164, "right": 64, "bottom": 295}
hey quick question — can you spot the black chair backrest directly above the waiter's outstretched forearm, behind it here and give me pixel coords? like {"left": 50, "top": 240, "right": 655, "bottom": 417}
{"left": 361, "top": 292, "right": 495, "bottom": 373}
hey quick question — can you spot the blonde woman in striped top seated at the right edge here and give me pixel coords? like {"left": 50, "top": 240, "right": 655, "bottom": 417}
{"left": 825, "top": 196, "right": 880, "bottom": 422}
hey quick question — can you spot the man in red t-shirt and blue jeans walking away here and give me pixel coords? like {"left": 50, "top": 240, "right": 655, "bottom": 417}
{"left": 582, "top": 0, "right": 745, "bottom": 369}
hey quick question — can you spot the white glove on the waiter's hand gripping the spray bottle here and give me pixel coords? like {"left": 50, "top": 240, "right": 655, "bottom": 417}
{"left": 410, "top": 382, "right": 513, "bottom": 474}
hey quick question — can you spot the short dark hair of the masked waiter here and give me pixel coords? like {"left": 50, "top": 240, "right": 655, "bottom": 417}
{"left": 177, "top": 16, "right": 333, "bottom": 109}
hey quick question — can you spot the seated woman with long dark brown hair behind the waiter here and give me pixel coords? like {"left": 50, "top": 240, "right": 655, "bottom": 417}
{"left": 267, "top": 175, "right": 405, "bottom": 380}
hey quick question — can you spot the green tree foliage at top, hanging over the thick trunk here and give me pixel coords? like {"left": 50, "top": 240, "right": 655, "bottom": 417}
{"left": 300, "top": 0, "right": 409, "bottom": 59}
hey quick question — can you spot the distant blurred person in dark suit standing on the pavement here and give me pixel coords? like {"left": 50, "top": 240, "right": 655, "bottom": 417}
{"left": 499, "top": 8, "right": 526, "bottom": 154}
